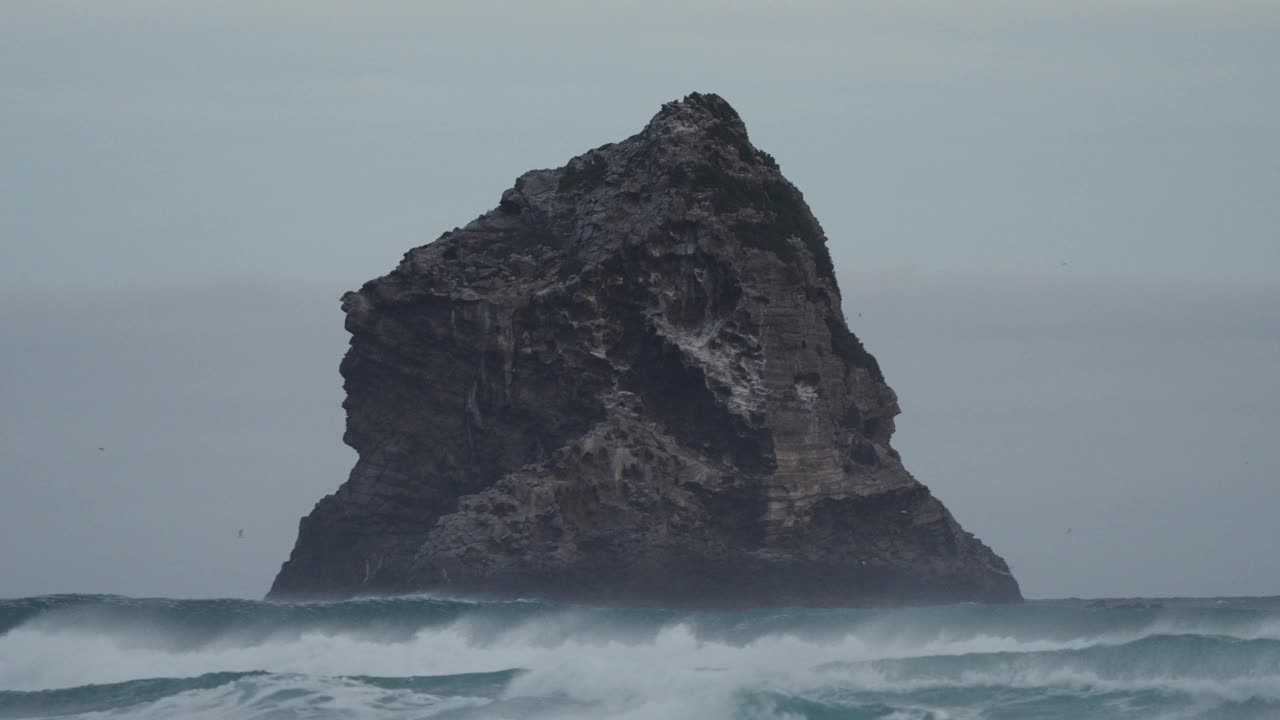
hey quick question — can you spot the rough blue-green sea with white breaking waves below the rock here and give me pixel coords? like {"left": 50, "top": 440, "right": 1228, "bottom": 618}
{"left": 0, "top": 596, "right": 1280, "bottom": 720}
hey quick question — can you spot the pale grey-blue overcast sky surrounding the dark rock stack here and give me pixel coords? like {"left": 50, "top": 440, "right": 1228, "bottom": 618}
{"left": 0, "top": 0, "right": 1280, "bottom": 597}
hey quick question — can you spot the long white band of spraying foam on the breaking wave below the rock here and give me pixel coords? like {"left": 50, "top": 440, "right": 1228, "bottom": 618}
{"left": 0, "top": 604, "right": 1274, "bottom": 691}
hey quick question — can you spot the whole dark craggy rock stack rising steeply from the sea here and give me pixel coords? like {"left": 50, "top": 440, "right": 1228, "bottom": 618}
{"left": 270, "top": 94, "right": 1020, "bottom": 607}
